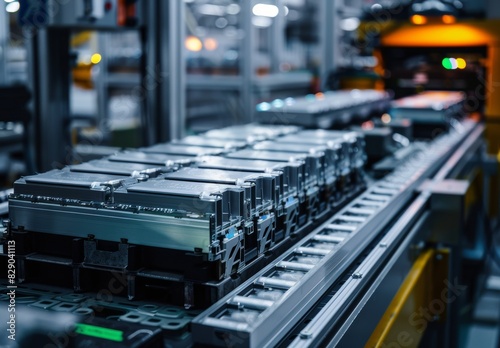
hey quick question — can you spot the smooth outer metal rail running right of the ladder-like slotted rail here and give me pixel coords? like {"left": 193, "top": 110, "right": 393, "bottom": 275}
{"left": 288, "top": 120, "right": 484, "bottom": 347}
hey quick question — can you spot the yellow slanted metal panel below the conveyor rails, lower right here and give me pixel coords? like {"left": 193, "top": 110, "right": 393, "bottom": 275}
{"left": 365, "top": 249, "right": 453, "bottom": 348}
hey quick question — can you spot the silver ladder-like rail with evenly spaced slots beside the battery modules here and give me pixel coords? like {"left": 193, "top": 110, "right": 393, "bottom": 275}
{"left": 192, "top": 122, "right": 475, "bottom": 347}
